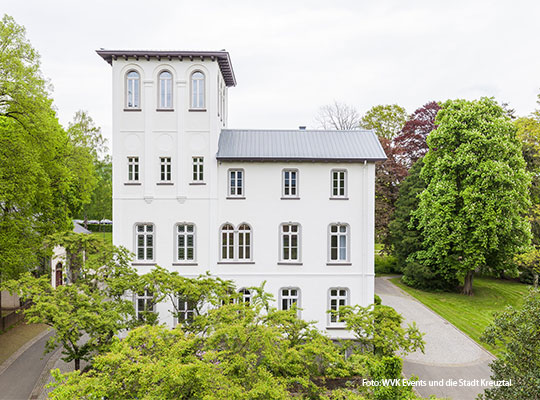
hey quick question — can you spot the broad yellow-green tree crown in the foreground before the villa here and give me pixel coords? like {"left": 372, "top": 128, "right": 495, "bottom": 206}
{"left": 50, "top": 276, "right": 426, "bottom": 400}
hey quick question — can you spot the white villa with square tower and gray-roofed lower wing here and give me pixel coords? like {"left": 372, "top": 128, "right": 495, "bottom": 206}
{"left": 97, "top": 49, "right": 386, "bottom": 337}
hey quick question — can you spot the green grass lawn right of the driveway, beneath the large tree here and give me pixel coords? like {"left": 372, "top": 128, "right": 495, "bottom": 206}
{"left": 391, "top": 277, "right": 529, "bottom": 354}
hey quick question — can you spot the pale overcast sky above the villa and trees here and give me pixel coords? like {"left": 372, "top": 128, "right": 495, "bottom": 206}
{"left": 4, "top": 0, "right": 540, "bottom": 144}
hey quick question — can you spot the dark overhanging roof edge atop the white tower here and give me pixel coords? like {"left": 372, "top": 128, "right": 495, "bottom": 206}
{"left": 96, "top": 49, "right": 236, "bottom": 86}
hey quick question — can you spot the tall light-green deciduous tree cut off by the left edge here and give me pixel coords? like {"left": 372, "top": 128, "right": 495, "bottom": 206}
{"left": 0, "top": 15, "right": 81, "bottom": 290}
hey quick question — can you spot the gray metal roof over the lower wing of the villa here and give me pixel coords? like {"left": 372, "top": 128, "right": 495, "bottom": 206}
{"left": 216, "top": 129, "right": 386, "bottom": 162}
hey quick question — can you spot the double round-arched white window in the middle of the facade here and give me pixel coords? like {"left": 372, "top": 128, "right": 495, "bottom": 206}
{"left": 219, "top": 222, "right": 253, "bottom": 263}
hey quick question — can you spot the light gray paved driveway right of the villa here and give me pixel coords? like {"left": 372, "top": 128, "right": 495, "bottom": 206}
{"left": 375, "top": 277, "right": 493, "bottom": 400}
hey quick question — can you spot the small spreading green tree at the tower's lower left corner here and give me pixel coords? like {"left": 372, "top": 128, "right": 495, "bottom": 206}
{"left": 3, "top": 232, "right": 138, "bottom": 370}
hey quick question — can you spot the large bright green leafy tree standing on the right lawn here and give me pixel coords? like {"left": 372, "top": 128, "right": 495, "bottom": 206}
{"left": 414, "top": 98, "right": 530, "bottom": 295}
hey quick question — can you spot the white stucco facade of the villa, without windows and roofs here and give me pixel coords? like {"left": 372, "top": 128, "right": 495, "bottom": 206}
{"left": 102, "top": 50, "right": 375, "bottom": 337}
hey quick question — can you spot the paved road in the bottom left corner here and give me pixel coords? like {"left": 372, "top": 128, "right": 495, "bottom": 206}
{"left": 0, "top": 332, "right": 53, "bottom": 400}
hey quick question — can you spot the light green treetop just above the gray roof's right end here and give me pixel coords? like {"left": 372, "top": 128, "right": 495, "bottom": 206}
{"left": 360, "top": 104, "right": 408, "bottom": 140}
